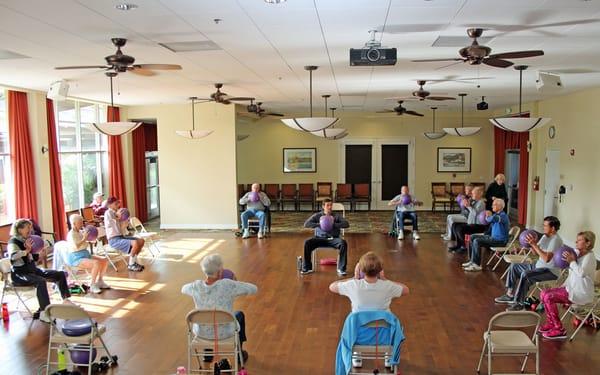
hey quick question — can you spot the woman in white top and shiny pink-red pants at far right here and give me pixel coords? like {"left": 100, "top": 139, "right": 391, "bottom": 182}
{"left": 539, "top": 231, "right": 596, "bottom": 339}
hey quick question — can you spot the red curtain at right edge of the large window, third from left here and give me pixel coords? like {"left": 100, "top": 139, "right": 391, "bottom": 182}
{"left": 107, "top": 106, "right": 127, "bottom": 207}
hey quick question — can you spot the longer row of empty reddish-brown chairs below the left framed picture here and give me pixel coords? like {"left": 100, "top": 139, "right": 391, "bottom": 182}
{"left": 238, "top": 182, "right": 371, "bottom": 211}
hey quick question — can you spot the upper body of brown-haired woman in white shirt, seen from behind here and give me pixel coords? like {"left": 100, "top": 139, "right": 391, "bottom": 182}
{"left": 329, "top": 251, "right": 409, "bottom": 312}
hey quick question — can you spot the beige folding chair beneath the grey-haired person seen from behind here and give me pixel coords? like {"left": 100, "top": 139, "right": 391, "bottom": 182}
{"left": 185, "top": 310, "right": 244, "bottom": 374}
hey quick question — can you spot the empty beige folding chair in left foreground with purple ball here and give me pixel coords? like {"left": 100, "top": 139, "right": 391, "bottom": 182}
{"left": 46, "top": 304, "right": 117, "bottom": 375}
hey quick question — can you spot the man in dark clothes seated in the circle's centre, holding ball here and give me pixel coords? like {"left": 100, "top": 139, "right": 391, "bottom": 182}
{"left": 300, "top": 198, "right": 350, "bottom": 276}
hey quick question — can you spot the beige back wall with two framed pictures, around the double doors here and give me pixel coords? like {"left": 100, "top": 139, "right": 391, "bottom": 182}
{"left": 237, "top": 111, "right": 493, "bottom": 208}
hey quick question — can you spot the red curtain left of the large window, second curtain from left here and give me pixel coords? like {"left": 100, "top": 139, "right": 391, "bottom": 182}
{"left": 46, "top": 99, "right": 67, "bottom": 240}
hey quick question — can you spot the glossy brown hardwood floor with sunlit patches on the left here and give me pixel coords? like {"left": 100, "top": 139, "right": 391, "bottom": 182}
{"left": 0, "top": 231, "right": 600, "bottom": 375}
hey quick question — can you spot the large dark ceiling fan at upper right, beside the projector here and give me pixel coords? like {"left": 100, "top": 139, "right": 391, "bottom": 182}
{"left": 413, "top": 28, "right": 544, "bottom": 68}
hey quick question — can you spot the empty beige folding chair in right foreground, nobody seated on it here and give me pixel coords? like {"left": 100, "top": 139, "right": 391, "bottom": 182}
{"left": 477, "top": 311, "right": 540, "bottom": 375}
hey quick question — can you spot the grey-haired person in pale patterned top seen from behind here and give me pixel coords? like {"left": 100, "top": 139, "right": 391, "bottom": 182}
{"left": 181, "top": 254, "right": 258, "bottom": 361}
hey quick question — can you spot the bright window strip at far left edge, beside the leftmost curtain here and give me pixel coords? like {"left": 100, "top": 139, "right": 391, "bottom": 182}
{"left": 0, "top": 90, "right": 15, "bottom": 225}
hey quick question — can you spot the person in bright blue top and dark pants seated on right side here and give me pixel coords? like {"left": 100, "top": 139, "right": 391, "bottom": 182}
{"left": 462, "top": 198, "right": 510, "bottom": 272}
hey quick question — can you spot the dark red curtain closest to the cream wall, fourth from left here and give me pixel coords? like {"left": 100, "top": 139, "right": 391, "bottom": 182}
{"left": 131, "top": 124, "right": 148, "bottom": 222}
